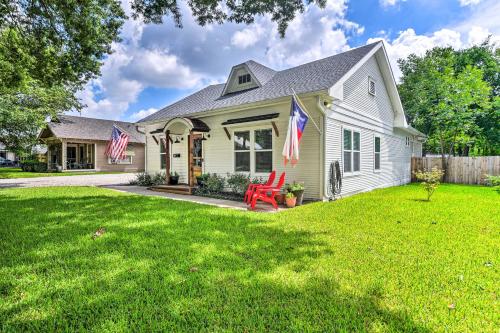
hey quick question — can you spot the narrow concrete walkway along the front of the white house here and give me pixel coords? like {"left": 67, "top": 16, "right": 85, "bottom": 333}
{"left": 103, "top": 185, "right": 286, "bottom": 213}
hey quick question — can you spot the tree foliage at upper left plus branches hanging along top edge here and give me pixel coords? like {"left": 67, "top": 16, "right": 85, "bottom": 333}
{"left": 0, "top": 0, "right": 326, "bottom": 150}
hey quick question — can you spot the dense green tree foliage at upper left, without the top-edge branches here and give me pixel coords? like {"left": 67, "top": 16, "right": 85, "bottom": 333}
{"left": 0, "top": 0, "right": 125, "bottom": 151}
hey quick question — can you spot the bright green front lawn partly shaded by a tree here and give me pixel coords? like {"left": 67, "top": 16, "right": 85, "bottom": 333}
{"left": 0, "top": 185, "right": 500, "bottom": 332}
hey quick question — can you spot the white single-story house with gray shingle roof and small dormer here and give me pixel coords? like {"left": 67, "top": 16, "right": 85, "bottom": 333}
{"left": 138, "top": 42, "right": 424, "bottom": 199}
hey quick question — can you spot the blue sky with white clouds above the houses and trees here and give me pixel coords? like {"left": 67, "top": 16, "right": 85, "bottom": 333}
{"left": 72, "top": 0, "right": 500, "bottom": 121}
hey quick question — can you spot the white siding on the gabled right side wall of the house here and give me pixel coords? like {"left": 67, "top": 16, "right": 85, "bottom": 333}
{"left": 324, "top": 53, "right": 412, "bottom": 195}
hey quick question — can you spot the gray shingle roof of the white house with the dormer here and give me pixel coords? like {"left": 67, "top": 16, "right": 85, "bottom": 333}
{"left": 139, "top": 42, "right": 379, "bottom": 122}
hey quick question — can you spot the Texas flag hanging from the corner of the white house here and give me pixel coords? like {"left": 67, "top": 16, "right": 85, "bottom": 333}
{"left": 282, "top": 96, "right": 309, "bottom": 166}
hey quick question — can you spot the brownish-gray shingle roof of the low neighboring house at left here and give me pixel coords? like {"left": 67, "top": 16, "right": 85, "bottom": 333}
{"left": 47, "top": 115, "right": 145, "bottom": 143}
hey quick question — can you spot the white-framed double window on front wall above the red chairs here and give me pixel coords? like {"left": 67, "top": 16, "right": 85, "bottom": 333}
{"left": 234, "top": 128, "right": 273, "bottom": 173}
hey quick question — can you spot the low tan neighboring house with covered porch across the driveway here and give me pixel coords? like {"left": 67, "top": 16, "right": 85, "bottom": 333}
{"left": 38, "top": 115, "right": 145, "bottom": 172}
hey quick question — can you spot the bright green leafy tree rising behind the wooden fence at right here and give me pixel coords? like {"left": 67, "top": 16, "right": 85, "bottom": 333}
{"left": 398, "top": 44, "right": 498, "bottom": 170}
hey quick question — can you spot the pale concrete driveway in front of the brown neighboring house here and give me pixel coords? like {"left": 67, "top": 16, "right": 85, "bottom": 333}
{"left": 0, "top": 173, "right": 135, "bottom": 188}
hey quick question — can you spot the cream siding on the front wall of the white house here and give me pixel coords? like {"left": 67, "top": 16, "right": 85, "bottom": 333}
{"left": 147, "top": 99, "right": 323, "bottom": 199}
